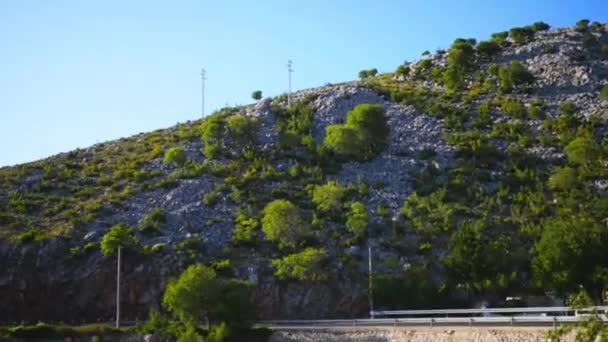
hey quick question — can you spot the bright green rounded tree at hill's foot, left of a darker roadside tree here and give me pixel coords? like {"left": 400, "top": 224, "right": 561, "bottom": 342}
{"left": 162, "top": 265, "right": 221, "bottom": 322}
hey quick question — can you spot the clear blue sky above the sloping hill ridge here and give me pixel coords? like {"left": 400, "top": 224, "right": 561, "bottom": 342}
{"left": 0, "top": 0, "right": 608, "bottom": 166}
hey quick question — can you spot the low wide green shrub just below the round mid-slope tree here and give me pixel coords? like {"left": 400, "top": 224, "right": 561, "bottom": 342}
{"left": 272, "top": 247, "right": 327, "bottom": 282}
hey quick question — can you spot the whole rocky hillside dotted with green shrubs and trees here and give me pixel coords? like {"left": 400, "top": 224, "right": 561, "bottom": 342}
{"left": 0, "top": 20, "right": 608, "bottom": 322}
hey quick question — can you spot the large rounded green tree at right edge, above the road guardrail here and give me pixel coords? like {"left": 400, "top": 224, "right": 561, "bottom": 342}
{"left": 532, "top": 212, "right": 608, "bottom": 294}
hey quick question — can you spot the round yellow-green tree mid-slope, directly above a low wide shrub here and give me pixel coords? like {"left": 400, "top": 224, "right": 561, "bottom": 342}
{"left": 262, "top": 200, "right": 309, "bottom": 248}
